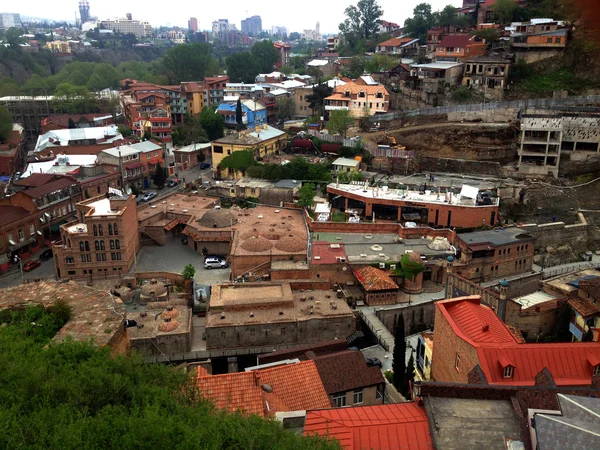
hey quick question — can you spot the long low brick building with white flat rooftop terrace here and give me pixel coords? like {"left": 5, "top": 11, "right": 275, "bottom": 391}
{"left": 327, "top": 183, "right": 499, "bottom": 228}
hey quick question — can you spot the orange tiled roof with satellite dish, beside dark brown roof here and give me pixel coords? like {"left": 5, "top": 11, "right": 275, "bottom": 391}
{"left": 197, "top": 361, "right": 331, "bottom": 417}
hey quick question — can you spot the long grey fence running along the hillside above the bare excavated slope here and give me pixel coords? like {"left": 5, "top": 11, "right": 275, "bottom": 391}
{"left": 370, "top": 95, "right": 600, "bottom": 122}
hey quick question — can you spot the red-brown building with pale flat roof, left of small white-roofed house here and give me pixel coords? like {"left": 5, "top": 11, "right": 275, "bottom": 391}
{"left": 98, "top": 141, "right": 165, "bottom": 188}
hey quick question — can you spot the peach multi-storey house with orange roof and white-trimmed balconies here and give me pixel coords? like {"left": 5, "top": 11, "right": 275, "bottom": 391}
{"left": 325, "top": 77, "right": 390, "bottom": 118}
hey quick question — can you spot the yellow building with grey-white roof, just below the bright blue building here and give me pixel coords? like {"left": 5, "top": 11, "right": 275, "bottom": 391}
{"left": 211, "top": 125, "right": 287, "bottom": 179}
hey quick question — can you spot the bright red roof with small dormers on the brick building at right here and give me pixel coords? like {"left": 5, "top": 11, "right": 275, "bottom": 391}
{"left": 435, "top": 297, "right": 600, "bottom": 386}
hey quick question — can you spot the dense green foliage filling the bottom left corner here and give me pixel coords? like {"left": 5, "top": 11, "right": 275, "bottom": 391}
{"left": 0, "top": 307, "right": 340, "bottom": 450}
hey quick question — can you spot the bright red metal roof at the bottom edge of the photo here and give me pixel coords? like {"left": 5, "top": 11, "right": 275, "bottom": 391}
{"left": 304, "top": 403, "right": 434, "bottom": 450}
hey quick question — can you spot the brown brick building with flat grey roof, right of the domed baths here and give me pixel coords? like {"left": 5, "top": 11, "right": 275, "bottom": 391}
{"left": 453, "top": 227, "right": 535, "bottom": 282}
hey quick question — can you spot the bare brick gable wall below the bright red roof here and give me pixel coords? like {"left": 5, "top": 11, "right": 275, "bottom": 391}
{"left": 431, "top": 298, "right": 479, "bottom": 383}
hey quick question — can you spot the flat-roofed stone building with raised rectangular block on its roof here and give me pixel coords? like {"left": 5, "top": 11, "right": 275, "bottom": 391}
{"left": 206, "top": 282, "right": 356, "bottom": 349}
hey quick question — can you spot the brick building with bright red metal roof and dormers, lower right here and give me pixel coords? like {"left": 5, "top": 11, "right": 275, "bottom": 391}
{"left": 431, "top": 297, "right": 600, "bottom": 386}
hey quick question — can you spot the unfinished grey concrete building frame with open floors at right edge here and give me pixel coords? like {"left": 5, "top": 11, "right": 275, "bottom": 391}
{"left": 519, "top": 111, "right": 600, "bottom": 177}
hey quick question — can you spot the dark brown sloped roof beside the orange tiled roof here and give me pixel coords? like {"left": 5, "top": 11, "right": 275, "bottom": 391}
{"left": 313, "top": 350, "right": 385, "bottom": 395}
